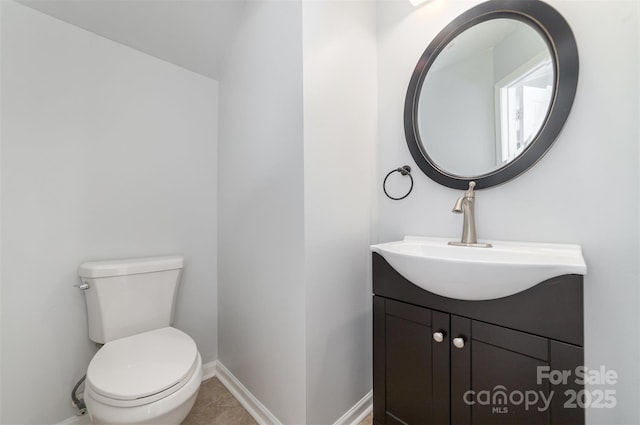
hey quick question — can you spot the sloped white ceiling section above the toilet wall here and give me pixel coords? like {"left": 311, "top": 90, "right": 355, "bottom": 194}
{"left": 19, "top": 0, "right": 244, "bottom": 79}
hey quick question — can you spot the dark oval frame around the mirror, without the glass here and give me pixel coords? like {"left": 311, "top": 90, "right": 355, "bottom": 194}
{"left": 404, "top": 0, "right": 579, "bottom": 189}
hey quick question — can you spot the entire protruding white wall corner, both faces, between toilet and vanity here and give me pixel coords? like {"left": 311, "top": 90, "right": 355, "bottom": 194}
{"left": 218, "top": 1, "right": 376, "bottom": 424}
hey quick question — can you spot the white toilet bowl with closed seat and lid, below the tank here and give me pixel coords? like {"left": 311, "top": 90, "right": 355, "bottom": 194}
{"left": 84, "top": 327, "right": 202, "bottom": 425}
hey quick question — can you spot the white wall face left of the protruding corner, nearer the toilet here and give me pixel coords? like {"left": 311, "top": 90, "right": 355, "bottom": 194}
{"left": 218, "top": 0, "right": 306, "bottom": 424}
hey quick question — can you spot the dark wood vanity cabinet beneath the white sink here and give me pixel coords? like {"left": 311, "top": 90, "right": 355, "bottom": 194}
{"left": 373, "top": 253, "right": 584, "bottom": 425}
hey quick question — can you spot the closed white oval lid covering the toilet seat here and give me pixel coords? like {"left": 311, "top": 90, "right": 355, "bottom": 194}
{"left": 87, "top": 327, "right": 198, "bottom": 400}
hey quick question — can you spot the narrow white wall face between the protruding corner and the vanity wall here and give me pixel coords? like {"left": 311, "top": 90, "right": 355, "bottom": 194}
{"left": 302, "top": 1, "right": 377, "bottom": 424}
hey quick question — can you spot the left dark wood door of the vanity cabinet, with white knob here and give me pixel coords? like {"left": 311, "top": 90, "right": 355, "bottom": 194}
{"left": 373, "top": 297, "right": 450, "bottom": 425}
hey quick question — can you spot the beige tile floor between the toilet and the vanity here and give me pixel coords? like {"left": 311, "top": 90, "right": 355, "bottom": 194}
{"left": 182, "top": 378, "right": 372, "bottom": 425}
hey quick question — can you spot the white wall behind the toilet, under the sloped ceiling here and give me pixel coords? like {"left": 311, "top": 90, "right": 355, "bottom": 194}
{"left": 0, "top": 0, "right": 218, "bottom": 424}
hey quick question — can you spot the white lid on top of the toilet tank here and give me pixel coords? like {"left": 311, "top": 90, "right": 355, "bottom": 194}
{"left": 78, "top": 255, "right": 184, "bottom": 278}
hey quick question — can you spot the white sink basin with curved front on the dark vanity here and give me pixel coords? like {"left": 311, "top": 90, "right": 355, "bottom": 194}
{"left": 371, "top": 236, "right": 587, "bottom": 300}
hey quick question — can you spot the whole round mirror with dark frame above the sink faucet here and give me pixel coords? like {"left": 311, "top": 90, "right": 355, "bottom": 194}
{"left": 405, "top": 0, "right": 578, "bottom": 189}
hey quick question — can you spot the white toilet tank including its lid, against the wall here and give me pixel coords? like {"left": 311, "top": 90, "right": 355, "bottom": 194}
{"left": 78, "top": 256, "right": 184, "bottom": 344}
